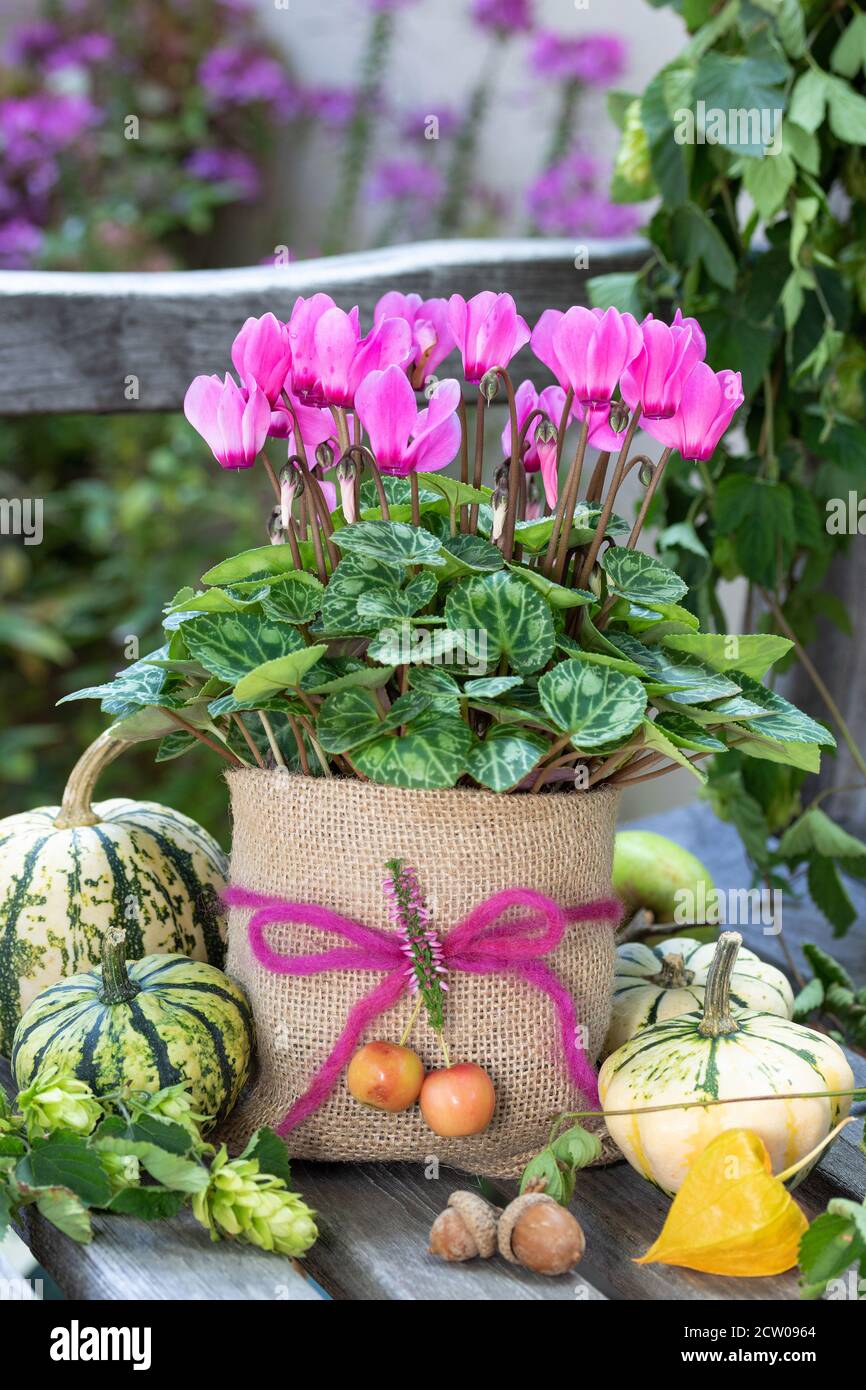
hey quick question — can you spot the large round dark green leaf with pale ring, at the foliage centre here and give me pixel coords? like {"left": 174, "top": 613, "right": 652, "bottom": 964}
{"left": 445, "top": 570, "right": 555, "bottom": 674}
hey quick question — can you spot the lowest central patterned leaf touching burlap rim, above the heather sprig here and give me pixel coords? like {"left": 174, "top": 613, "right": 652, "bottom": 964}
{"left": 352, "top": 710, "right": 471, "bottom": 790}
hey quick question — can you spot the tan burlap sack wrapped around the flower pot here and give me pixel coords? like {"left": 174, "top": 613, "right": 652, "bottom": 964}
{"left": 224, "top": 770, "right": 617, "bottom": 1177}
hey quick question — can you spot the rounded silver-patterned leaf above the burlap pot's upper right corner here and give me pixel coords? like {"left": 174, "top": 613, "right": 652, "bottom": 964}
{"left": 538, "top": 659, "right": 646, "bottom": 751}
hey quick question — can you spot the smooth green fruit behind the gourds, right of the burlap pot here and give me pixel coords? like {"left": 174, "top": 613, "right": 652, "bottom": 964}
{"left": 613, "top": 830, "right": 714, "bottom": 923}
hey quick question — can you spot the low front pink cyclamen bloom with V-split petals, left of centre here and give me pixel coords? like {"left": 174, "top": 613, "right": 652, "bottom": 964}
{"left": 356, "top": 364, "right": 460, "bottom": 478}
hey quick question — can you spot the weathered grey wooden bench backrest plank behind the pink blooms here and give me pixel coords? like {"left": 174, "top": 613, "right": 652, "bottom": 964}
{"left": 0, "top": 238, "right": 646, "bottom": 416}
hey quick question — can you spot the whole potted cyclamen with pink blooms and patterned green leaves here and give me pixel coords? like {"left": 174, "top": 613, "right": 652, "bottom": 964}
{"left": 67, "top": 291, "right": 834, "bottom": 794}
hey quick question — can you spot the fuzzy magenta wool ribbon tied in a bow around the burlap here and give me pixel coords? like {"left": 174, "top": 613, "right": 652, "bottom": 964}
{"left": 224, "top": 885, "right": 623, "bottom": 1134}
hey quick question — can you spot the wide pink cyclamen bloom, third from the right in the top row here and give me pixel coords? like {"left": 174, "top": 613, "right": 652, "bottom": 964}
{"left": 532, "top": 306, "right": 644, "bottom": 406}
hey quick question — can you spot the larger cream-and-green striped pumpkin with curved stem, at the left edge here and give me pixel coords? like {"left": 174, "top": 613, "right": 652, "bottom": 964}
{"left": 0, "top": 734, "right": 228, "bottom": 1056}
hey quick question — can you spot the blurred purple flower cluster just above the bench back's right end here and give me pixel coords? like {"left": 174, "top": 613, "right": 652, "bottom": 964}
{"left": 527, "top": 150, "right": 638, "bottom": 236}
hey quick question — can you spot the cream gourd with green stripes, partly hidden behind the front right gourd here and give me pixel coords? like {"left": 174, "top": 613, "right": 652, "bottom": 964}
{"left": 603, "top": 937, "right": 794, "bottom": 1056}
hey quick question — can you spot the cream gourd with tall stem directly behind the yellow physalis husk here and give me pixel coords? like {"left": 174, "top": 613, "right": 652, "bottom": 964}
{"left": 599, "top": 931, "right": 853, "bottom": 1195}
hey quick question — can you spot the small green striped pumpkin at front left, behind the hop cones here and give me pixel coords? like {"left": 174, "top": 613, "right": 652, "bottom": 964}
{"left": 13, "top": 927, "right": 253, "bottom": 1119}
